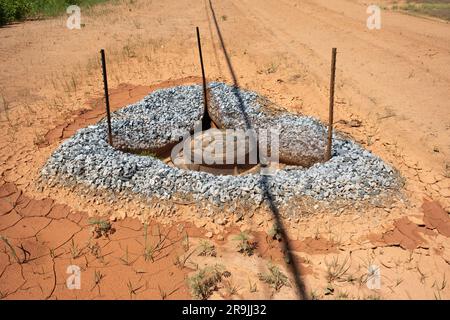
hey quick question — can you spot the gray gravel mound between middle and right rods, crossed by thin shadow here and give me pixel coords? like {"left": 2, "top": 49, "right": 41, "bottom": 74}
{"left": 208, "top": 83, "right": 327, "bottom": 167}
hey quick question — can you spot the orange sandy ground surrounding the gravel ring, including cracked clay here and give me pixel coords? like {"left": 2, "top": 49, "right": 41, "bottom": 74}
{"left": 0, "top": 0, "right": 450, "bottom": 299}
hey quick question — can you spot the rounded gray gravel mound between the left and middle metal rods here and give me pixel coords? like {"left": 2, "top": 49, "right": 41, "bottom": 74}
{"left": 111, "top": 85, "right": 204, "bottom": 151}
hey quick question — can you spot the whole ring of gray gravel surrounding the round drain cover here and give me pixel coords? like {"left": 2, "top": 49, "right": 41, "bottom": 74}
{"left": 41, "top": 83, "right": 399, "bottom": 206}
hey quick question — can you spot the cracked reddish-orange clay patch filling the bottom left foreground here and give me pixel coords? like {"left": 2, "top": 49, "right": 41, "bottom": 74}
{"left": 0, "top": 179, "right": 199, "bottom": 299}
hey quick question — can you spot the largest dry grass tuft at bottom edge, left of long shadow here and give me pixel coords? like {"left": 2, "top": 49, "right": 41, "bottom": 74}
{"left": 188, "top": 264, "right": 225, "bottom": 300}
